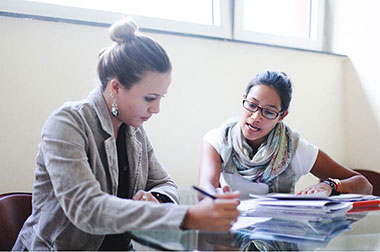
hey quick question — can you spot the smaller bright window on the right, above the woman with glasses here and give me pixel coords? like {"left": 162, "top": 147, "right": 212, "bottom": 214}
{"left": 234, "top": 0, "right": 324, "bottom": 50}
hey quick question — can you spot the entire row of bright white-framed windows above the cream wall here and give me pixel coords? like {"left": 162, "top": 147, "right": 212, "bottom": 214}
{"left": 0, "top": 0, "right": 325, "bottom": 51}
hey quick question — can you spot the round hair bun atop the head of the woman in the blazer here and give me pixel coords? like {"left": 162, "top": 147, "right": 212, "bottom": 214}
{"left": 110, "top": 19, "right": 139, "bottom": 44}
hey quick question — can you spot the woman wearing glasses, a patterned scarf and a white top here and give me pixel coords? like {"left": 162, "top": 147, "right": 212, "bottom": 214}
{"left": 199, "top": 71, "right": 372, "bottom": 199}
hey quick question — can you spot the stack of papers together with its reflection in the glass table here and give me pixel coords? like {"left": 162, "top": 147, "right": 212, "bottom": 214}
{"left": 235, "top": 194, "right": 352, "bottom": 250}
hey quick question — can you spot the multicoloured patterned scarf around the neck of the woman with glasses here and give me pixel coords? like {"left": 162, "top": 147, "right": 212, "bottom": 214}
{"left": 222, "top": 117, "right": 298, "bottom": 184}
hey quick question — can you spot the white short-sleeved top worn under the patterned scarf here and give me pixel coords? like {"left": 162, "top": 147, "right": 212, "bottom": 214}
{"left": 203, "top": 128, "right": 319, "bottom": 198}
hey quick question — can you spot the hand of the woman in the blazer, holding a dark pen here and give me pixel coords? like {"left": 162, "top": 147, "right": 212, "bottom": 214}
{"left": 181, "top": 192, "right": 240, "bottom": 232}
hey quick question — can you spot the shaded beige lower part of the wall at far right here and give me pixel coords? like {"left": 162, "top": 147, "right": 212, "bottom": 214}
{"left": 343, "top": 58, "right": 380, "bottom": 172}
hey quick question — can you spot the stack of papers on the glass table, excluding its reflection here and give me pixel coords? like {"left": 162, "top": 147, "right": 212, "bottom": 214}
{"left": 238, "top": 194, "right": 352, "bottom": 221}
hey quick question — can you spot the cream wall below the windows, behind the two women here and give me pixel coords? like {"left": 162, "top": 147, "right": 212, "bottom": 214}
{"left": 0, "top": 17, "right": 348, "bottom": 193}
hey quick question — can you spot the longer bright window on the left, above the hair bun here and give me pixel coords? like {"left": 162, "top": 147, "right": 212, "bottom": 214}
{"left": 0, "top": 0, "right": 231, "bottom": 38}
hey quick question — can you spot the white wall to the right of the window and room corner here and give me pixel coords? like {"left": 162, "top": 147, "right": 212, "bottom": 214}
{"left": 327, "top": 0, "right": 380, "bottom": 172}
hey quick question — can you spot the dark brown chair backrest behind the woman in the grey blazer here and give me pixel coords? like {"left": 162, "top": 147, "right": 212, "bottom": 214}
{"left": 0, "top": 193, "right": 32, "bottom": 251}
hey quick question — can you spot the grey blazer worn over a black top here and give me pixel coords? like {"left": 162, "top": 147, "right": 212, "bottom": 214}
{"left": 13, "top": 88, "right": 188, "bottom": 250}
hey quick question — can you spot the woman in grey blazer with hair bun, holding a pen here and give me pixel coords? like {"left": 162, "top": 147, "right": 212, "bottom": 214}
{"left": 13, "top": 20, "right": 239, "bottom": 251}
